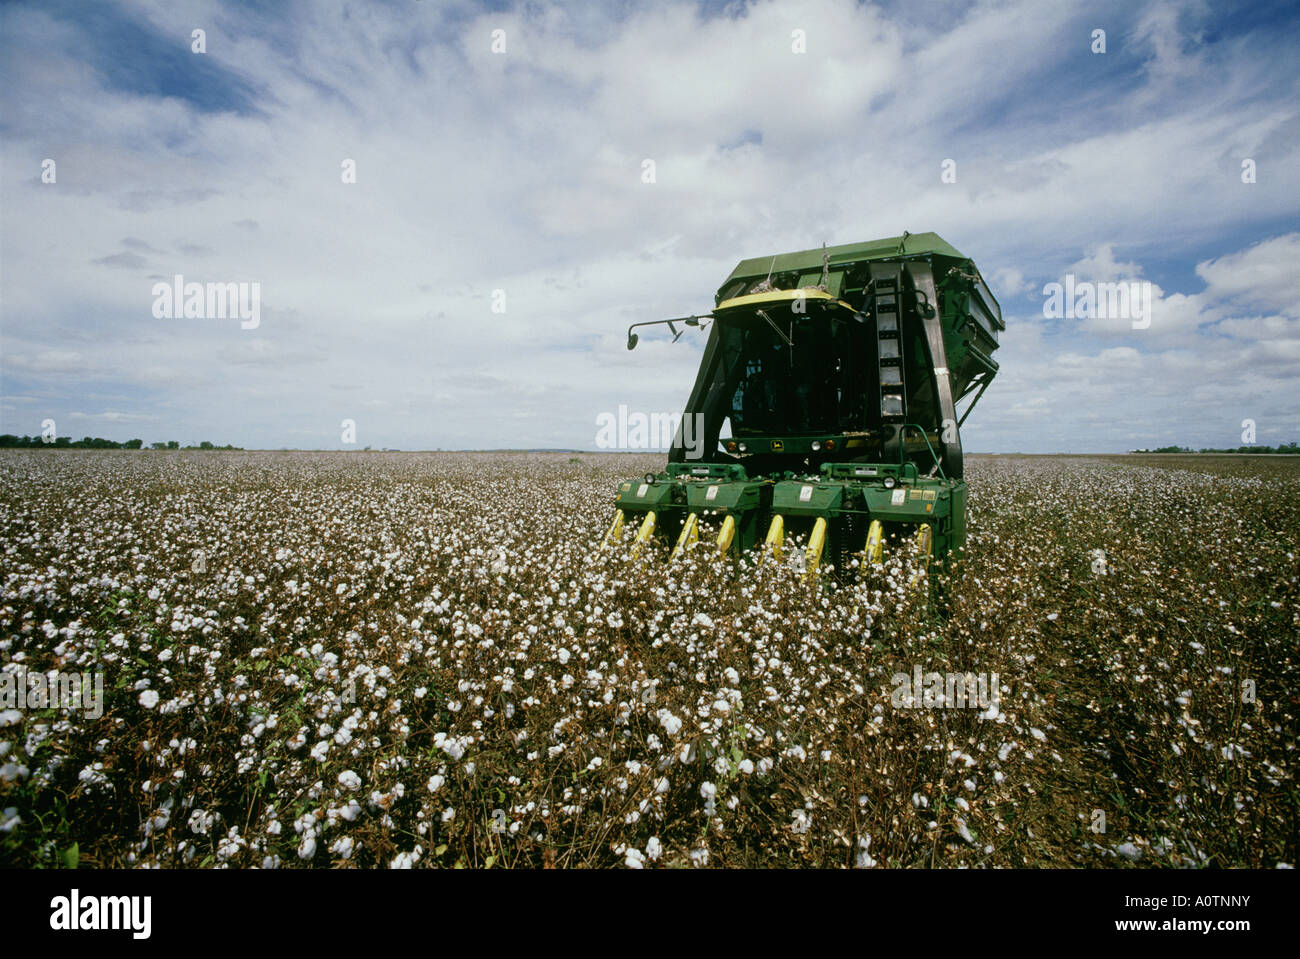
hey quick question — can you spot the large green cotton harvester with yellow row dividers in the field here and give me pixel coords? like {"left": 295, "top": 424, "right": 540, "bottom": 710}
{"left": 603, "top": 233, "right": 1006, "bottom": 577}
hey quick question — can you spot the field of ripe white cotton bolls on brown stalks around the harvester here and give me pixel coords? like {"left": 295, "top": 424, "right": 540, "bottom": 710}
{"left": 0, "top": 451, "right": 1300, "bottom": 869}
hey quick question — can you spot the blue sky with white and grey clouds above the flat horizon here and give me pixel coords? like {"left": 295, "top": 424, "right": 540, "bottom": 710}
{"left": 0, "top": 0, "right": 1300, "bottom": 452}
